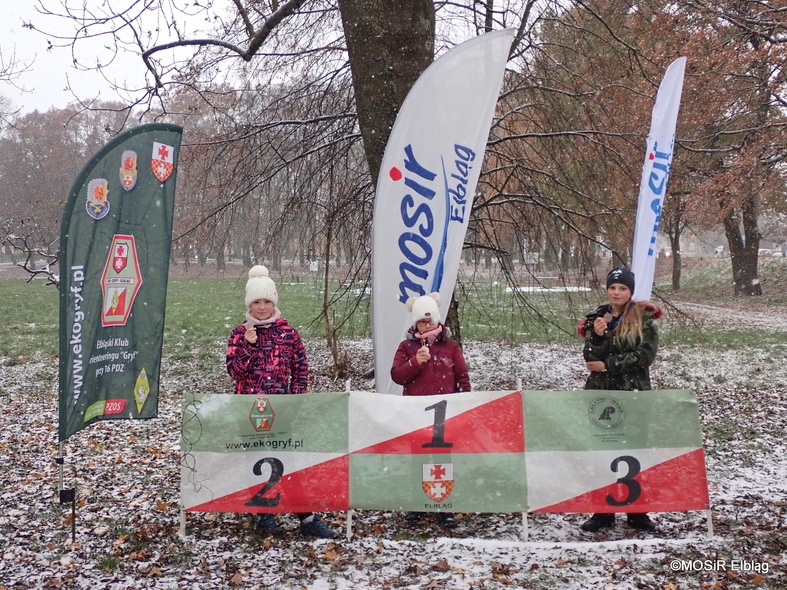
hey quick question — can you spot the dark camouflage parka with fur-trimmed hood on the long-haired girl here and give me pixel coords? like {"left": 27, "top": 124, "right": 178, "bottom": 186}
{"left": 577, "top": 301, "right": 663, "bottom": 391}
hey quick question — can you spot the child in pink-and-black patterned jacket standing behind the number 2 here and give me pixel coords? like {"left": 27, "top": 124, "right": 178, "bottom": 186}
{"left": 226, "top": 265, "right": 336, "bottom": 539}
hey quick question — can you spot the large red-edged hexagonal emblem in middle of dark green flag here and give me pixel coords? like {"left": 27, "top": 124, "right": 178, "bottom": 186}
{"left": 101, "top": 235, "right": 142, "bottom": 327}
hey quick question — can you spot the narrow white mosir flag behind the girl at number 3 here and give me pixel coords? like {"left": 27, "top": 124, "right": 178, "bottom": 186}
{"left": 631, "top": 57, "right": 686, "bottom": 301}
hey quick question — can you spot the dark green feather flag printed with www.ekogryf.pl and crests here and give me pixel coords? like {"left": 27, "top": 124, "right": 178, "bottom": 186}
{"left": 59, "top": 123, "right": 183, "bottom": 441}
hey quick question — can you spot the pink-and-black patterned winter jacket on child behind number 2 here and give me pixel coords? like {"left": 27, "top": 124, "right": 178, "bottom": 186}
{"left": 226, "top": 318, "right": 309, "bottom": 395}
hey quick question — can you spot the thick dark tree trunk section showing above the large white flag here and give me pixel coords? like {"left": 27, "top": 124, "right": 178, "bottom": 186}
{"left": 339, "top": 0, "right": 435, "bottom": 181}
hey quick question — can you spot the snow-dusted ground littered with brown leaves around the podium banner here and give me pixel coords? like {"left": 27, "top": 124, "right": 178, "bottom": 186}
{"left": 0, "top": 306, "right": 787, "bottom": 590}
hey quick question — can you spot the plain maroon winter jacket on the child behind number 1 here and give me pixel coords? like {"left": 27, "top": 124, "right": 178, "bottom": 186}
{"left": 391, "top": 327, "right": 470, "bottom": 395}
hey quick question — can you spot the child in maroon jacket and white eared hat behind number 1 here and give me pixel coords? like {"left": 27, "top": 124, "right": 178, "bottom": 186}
{"left": 391, "top": 293, "right": 470, "bottom": 528}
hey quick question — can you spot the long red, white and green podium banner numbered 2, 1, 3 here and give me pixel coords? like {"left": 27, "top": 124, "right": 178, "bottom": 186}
{"left": 181, "top": 390, "right": 709, "bottom": 512}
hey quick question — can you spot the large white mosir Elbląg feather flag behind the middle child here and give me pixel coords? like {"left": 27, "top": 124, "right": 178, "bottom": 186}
{"left": 372, "top": 29, "right": 514, "bottom": 393}
